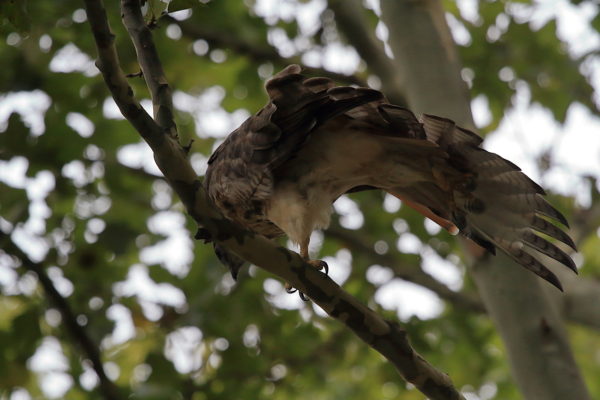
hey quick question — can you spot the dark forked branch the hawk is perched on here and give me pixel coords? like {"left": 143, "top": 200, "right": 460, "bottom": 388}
{"left": 85, "top": 0, "right": 464, "bottom": 400}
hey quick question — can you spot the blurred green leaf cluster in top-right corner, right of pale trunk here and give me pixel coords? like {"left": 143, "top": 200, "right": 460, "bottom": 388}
{"left": 445, "top": 1, "right": 599, "bottom": 131}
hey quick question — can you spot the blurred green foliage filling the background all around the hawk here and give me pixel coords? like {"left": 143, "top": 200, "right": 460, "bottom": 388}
{"left": 0, "top": 0, "right": 600, "bottom": 400}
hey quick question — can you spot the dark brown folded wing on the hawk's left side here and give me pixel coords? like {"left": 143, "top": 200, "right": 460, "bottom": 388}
{"left": 205, "top": 65, "right": 383, "bottom": 237}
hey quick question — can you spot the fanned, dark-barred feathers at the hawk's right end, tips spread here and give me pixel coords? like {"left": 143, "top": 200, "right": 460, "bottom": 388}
{"left": 386, "top": 109, "right": 577, "bottom": 290}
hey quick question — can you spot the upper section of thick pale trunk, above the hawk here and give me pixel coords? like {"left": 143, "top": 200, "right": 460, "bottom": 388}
{"left": 381, "top": 0, "right": 474, "bottom": 128}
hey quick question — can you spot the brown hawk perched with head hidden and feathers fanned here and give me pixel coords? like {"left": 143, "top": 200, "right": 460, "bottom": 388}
{"left": 204, "top": 65, "right": 577, "bottom": 290}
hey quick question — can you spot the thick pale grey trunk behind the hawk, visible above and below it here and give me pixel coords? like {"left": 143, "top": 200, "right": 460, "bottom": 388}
{"left": 382, "top": 0, "right": 589, "bottom": 400}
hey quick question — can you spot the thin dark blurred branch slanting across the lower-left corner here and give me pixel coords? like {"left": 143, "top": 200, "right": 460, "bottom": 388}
{"left": 0, "top": 231, "right": 122, "bottom": 400}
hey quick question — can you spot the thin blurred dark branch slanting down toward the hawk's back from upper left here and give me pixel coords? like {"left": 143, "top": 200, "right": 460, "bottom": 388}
{"left": 161, "top": 15, "right": 367, "bottom": 86}
